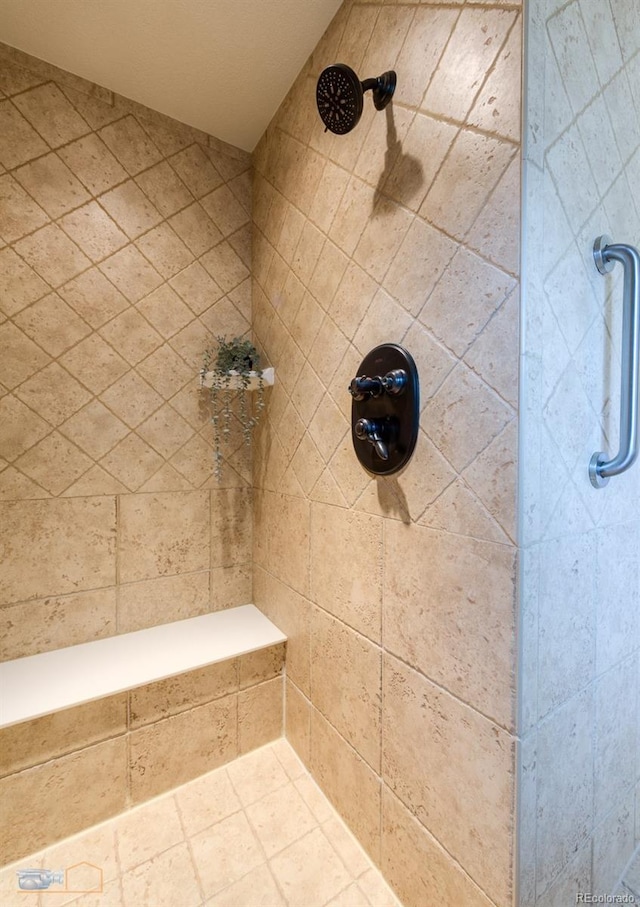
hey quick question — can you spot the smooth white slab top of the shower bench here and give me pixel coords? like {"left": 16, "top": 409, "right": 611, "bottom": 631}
{"left": 0, "top": 605, "right": 286, "bottom": 728}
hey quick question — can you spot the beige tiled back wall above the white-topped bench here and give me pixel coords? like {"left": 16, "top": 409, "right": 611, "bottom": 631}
{"left": 0, "top": 46, "right": 251, "bottom": 659}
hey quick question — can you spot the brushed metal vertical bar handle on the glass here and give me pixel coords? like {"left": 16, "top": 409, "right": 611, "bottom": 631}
{"left": 589, "top": 236, "right": 640, "bottom": 488}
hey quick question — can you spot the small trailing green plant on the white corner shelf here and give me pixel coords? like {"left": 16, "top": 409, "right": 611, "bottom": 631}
{"left": 200, "top": 337, "right": 264, "bottom": 481}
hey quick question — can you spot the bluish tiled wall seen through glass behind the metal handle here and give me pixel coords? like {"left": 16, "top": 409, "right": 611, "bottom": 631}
{"left": 520, "top": 0, "right": 640, "bottom": 907}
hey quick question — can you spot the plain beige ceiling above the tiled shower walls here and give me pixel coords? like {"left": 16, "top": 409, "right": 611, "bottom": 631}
{"left": 0, "top": 0, "right": 341, "bottom": 151}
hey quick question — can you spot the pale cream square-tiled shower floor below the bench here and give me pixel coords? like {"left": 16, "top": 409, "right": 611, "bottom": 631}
{"left": 0, "top": 739, "right": 401, "bottom": 907}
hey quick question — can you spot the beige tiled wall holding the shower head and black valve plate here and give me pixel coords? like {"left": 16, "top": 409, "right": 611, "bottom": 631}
{"left": 253, "top": 0, "right": 522, "bottom": 907}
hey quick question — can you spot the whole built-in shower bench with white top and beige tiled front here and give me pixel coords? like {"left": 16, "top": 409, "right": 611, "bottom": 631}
{"left": 0, "top": 605, "right": 286, "bottom": 864}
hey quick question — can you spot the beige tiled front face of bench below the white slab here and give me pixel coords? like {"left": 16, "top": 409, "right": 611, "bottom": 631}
{"left": 0, "top": 645, "right": 284, "bottom": 865}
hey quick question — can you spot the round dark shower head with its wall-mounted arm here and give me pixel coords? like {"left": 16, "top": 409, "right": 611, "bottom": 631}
{"left": 316, "top": 63, "right": 396, "bottom": 135}
